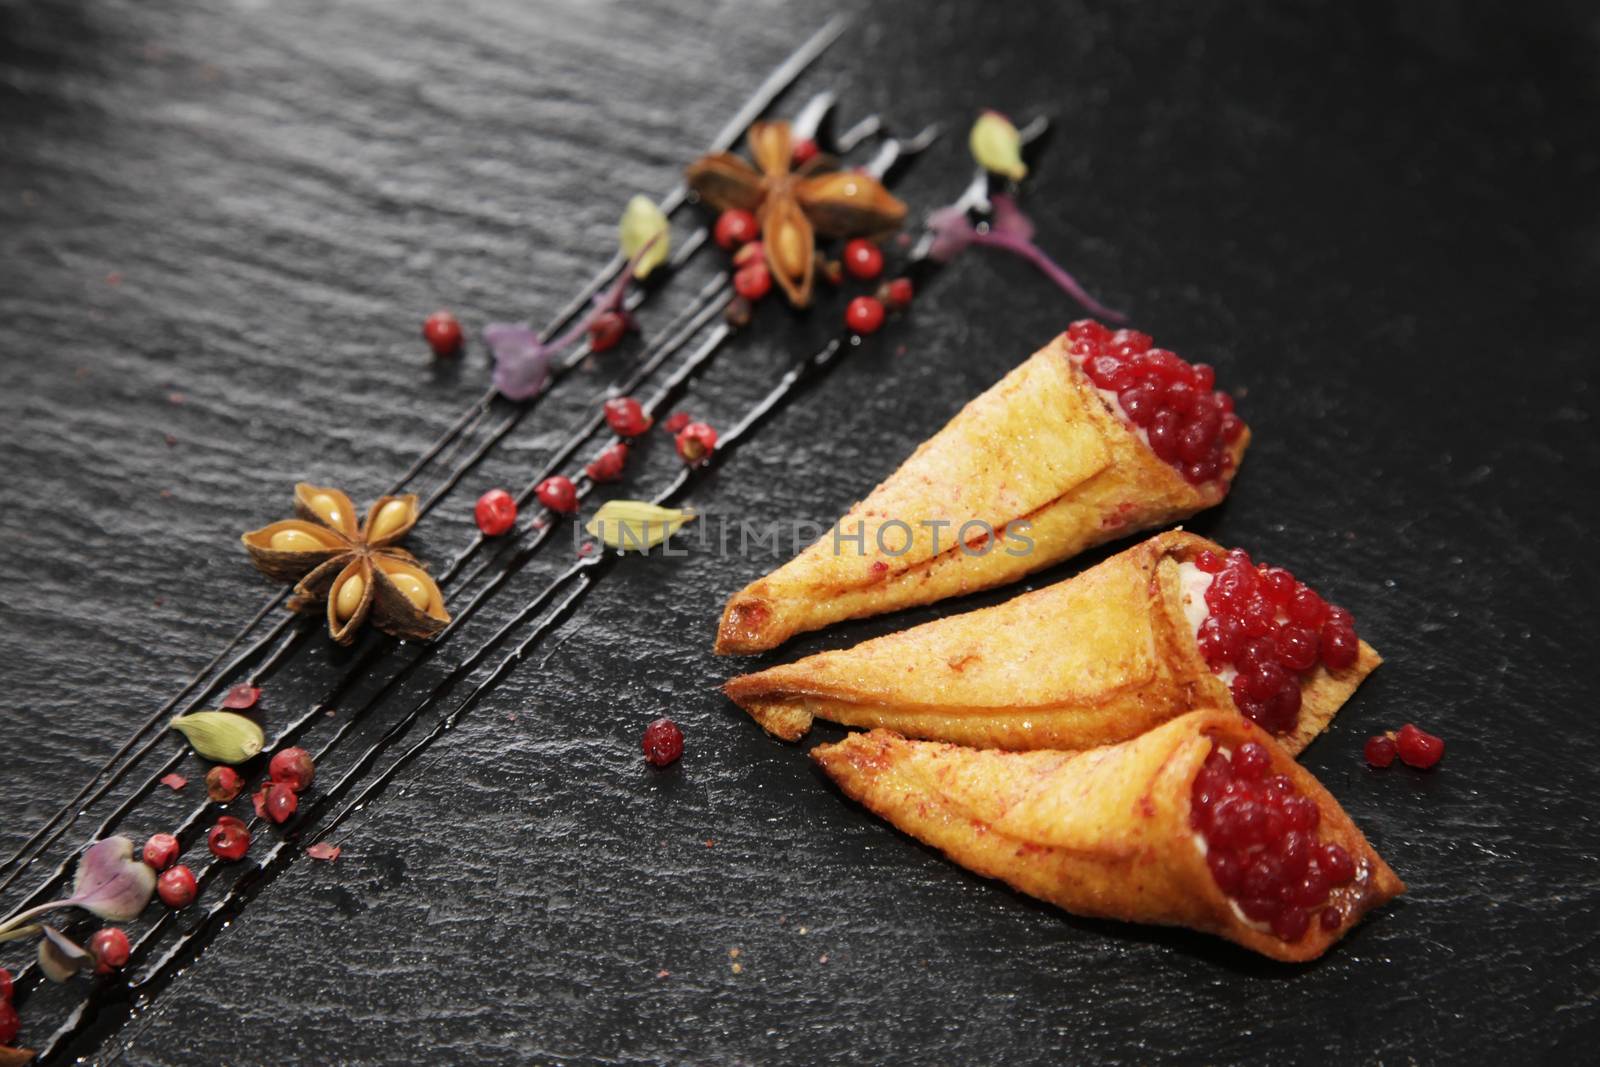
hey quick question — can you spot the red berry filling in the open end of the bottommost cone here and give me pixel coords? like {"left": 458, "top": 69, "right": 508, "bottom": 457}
{"left": 1189, "top": 741, "right": 1355, "bottom": 941}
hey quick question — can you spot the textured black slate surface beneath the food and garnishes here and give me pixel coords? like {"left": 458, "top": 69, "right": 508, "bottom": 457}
{"left": 0, "top": 0, "right": 1600, "bottom": 1064}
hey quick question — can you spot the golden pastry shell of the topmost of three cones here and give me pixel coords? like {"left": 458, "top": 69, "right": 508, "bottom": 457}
{"left": 717, "top": 334, "right": 1250, "bottom": 654}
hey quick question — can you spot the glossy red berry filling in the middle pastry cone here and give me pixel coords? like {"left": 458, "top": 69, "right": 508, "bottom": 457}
{"left": 1184, "top": 549, "right": 1360, "bottom": 734}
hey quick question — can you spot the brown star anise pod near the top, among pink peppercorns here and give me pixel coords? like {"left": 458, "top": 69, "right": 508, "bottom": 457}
{"left": 688, "top": 122, "right": 906, "bottom": 307}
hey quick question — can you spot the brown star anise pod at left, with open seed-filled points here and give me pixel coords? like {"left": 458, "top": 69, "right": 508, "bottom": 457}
{"left": 242, "top": 482, "right": 450, "bottom": 645}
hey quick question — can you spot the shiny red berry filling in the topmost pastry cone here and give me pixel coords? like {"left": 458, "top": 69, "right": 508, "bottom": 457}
{"left": 1067, "top": 318, "right": 1245, "bottom": 485}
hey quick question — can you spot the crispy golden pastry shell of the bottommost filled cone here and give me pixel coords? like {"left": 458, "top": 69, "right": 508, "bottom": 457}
{"left": 811, "top": 710, "right": 1405, "bottom": 961}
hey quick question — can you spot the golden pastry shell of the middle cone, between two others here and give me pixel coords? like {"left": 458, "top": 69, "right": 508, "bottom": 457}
{"left": 723, "top": 531, "right": 1381, "bottom": 753}
